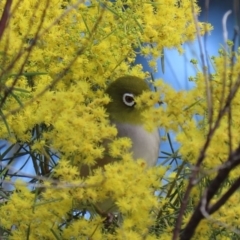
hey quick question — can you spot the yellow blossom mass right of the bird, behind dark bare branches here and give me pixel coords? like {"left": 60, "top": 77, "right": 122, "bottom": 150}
{"left": 152, "top": 50, "right": 240, "bottom": 236}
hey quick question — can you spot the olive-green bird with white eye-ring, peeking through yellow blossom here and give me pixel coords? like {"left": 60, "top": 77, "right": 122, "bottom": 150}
{"left": 81, "top": 75, "right": 160, "bottom": 214}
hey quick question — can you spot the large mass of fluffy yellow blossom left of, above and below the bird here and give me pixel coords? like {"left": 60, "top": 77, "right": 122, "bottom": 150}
{"left": 0, "top": 0, "right": 210, "bottom": 239}
